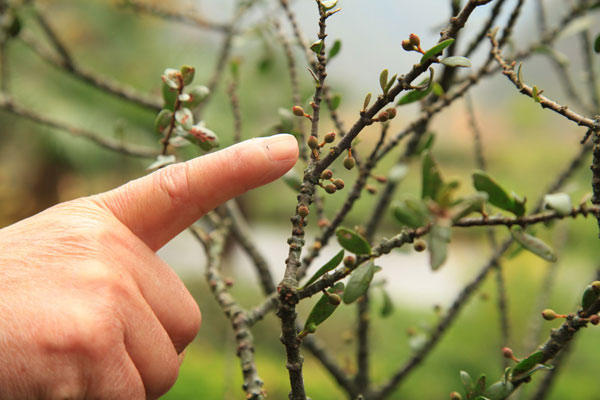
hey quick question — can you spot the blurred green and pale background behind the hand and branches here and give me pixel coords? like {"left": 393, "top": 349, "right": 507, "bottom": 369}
{"left": 0, "top": 0, "right": 600, "bottom": 399}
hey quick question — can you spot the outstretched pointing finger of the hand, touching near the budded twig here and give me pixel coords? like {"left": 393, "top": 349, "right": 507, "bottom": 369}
{"left": 95, "top": 134, "right": 298, "bottom": 250}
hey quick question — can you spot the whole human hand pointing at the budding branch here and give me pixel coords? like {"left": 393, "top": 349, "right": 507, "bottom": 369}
{"left": 0, "top": 135, "right": 298, "bottom": 400}
